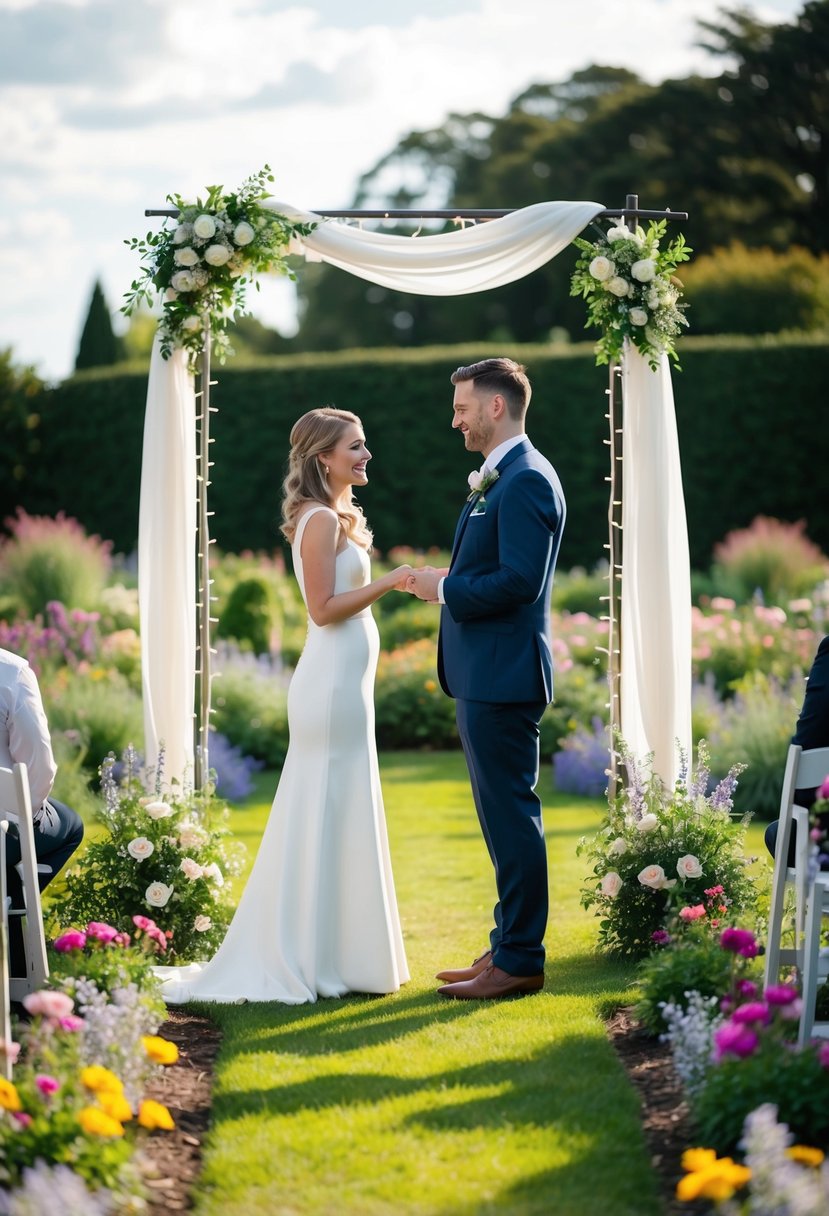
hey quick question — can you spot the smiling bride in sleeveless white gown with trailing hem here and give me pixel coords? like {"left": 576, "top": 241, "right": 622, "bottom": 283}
{"left": 157, "top": 406, "right": 411, "bottom": 1004}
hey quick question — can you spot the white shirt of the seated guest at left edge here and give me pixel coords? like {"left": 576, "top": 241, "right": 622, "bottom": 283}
{"left": 0, "top": 649, "right": 57, "bottom": 820}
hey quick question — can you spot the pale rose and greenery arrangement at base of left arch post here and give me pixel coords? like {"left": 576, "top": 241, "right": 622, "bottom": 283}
{"left": 49, "top": 748, "right": 243, "bottom": 962}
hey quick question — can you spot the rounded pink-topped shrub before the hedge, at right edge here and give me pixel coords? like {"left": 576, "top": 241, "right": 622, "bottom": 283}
{"left": 712, "top": 516, "right": 829, "bottom": 604}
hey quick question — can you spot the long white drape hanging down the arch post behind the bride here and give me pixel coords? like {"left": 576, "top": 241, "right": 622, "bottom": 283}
{"left": 139, "top": 336, "right": 196, "bottom": 786}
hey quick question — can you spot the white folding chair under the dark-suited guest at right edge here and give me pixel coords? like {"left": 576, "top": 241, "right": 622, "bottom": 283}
{"left": 763, "top": 743, "right": 829, "bottom": 987}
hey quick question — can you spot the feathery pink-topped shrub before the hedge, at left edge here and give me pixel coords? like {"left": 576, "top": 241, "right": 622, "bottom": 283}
{"left": 0, "top": 508, "right": 112, "bottom": 617}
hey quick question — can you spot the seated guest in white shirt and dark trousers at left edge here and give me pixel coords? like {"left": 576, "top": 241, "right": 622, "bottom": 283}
{"left": 0, "top": 649, "right": 84, "bottom": 975}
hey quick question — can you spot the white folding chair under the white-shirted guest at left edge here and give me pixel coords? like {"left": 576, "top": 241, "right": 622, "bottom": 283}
{"left": 0, "top": 764, "right": 49, "bottom": 1018}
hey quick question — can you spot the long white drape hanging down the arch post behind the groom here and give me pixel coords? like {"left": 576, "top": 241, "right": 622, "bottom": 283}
{"left": 621, "top": 343, "right": 692, "bottom": 787}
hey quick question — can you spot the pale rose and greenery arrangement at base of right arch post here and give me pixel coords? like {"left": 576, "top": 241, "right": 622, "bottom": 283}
{"left": 577, "top": 739, "right": 752, "bottom": 957}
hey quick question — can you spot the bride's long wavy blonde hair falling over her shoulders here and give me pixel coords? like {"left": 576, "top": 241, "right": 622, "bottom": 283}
{"left": 281, "top": 405, "right": 372, "bottom": 548}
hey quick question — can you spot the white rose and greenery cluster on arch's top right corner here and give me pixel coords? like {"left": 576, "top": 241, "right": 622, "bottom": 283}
{"left": 570, "top": 220, "right": 693, "bottom": 371}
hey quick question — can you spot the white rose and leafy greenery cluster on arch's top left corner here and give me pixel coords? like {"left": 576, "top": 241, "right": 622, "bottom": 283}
{"left": 122, "top": 165, "right": 314, "bottom": 364}
